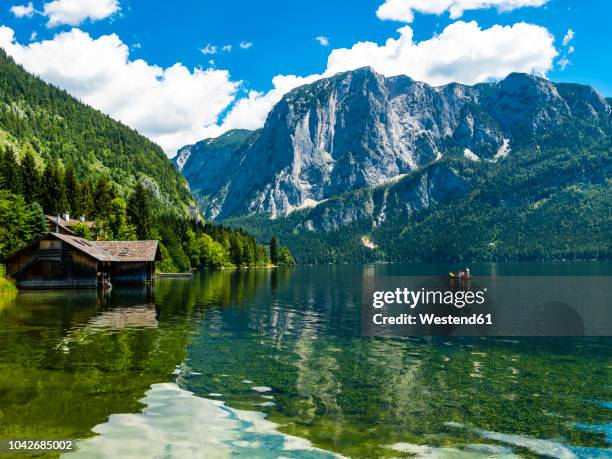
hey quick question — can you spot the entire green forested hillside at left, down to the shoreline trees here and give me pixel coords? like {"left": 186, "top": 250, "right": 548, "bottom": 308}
{"left": 0, "top": 50, "right": 269, "bottom": 271}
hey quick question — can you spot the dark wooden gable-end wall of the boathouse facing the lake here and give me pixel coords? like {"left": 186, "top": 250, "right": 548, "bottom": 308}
{"left": 7, "top": 239, "right": 99, "bottom": 289}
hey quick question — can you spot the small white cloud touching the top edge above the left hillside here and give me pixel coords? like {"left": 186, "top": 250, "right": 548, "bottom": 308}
{"left": 42, "top": 0, "right": 120, "bottom": 27}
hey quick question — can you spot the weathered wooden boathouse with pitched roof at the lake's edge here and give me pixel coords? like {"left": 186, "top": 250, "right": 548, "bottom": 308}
{"left": 6, "top": 233, "right": 161, "bottom": 289}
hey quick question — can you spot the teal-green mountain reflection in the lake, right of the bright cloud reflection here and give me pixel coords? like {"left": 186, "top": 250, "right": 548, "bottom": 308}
{"left": 183, "top": 266, "right": 610, "bottom": 457}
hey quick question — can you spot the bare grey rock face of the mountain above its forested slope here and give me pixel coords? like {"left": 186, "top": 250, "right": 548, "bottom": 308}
{"left": 175, "top": 68, "right": 611, "bottom": 223}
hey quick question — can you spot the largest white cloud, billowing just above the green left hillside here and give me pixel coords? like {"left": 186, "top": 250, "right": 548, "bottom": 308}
{"left": 0, "top": 26, "right": 240, "bottom": 154}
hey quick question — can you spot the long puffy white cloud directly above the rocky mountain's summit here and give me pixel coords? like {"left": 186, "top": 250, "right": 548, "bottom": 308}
{"left": 326, "top": 21, "right": 557, "bottom": 85}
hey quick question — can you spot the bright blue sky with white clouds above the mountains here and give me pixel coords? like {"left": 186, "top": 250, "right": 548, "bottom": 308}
{"left": 0, "top": 0, "right": 612, "bottom": 157}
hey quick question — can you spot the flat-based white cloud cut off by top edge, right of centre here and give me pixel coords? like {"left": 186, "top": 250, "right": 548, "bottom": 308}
{"left": 376, "top": 0, "right": 548, "bottom": 22}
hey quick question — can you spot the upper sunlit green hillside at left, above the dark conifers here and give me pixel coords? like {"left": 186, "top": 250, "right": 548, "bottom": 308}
{"left": 0, "top": 50, "right": 192, "bottom": 215}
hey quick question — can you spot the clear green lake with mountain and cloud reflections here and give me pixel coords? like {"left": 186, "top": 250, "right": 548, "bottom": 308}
{"left": 0, "top": 262, "right": 612, "bottom": 458}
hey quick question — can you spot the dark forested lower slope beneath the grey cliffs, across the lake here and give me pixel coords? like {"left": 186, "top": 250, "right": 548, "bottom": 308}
{"left": 225, "top": 138, "right": 612, "bottom": 263}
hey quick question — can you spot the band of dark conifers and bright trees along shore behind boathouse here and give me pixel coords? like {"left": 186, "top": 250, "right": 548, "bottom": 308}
{"left": 0, "top": 150, "right": 269, "bottom": 271}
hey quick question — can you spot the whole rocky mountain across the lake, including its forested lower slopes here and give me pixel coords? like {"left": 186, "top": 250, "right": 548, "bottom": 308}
{"left": 175, "top": 68, "right": 612, "bottom": 263}
